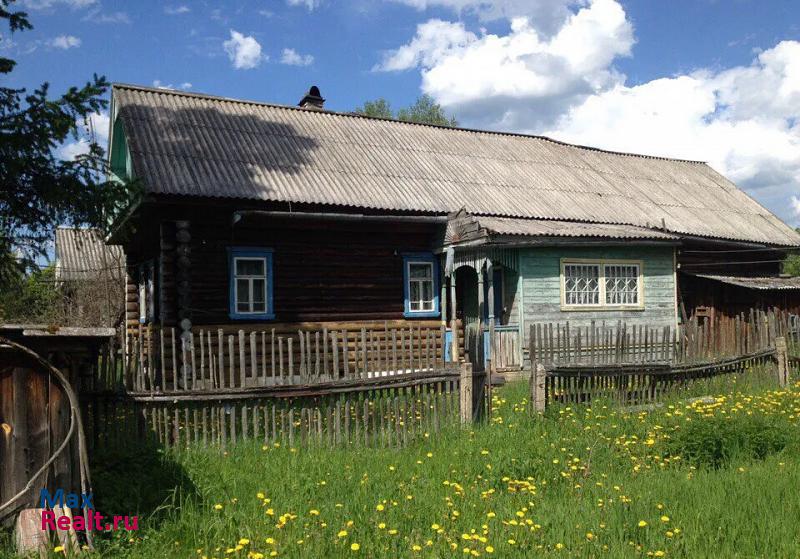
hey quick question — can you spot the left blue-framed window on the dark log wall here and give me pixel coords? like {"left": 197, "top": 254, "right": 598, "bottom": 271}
{"left": 228, "top": 247, "right": 275, "bottom": 320}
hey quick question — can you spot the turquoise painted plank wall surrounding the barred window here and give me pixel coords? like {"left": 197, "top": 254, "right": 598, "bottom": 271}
{"left": 518, "top": 246, "right": 676, "bottom": 342}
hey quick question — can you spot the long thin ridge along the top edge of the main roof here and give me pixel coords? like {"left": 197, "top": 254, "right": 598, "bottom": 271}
{"left": 111, "top": 82, "right": 708, "bottom": 165}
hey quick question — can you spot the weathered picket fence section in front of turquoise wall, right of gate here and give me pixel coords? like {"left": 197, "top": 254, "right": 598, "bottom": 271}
{"left": 529, "top": 311, "right": 800, "bottom": 410}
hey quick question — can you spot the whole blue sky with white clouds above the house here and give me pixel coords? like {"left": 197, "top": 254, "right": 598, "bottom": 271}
{"left": 0, "top": 0, "right": 800, "bottom": 225}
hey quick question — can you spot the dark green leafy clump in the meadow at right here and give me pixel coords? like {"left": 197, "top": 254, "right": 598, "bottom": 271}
{"left": 668, "top": 415, "right": 792, "bottom": 469}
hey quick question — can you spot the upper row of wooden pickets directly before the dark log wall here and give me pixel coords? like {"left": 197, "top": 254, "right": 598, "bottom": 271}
{"left": 121, "top": 323, "right": 454, "bottom": 393}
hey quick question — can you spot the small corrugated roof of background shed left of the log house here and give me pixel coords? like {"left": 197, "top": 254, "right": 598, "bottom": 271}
{"left": 56, "top": 227, "right": 125, "bottom": 281}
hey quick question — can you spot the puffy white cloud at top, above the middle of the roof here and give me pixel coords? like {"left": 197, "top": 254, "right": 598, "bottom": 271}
{"left": 377, "top": 0, "right": 634, "bottom": 129}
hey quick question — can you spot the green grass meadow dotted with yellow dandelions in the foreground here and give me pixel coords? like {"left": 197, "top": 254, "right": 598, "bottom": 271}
{"left": 6, "top": 371, "right": 800, "bottom": 558}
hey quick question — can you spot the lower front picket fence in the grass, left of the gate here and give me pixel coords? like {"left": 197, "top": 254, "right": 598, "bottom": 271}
{"left": 84, "top": 363, "right": 491, "bottom": 448}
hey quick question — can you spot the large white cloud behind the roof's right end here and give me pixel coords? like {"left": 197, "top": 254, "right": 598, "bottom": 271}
{"left": 545, "top": 41, "right": 800, "bottom": 224}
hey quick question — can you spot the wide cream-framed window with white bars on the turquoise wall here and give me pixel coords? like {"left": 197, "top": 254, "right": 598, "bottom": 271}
{"left": 561, "top": 260, "right": 643, "bottom": 309}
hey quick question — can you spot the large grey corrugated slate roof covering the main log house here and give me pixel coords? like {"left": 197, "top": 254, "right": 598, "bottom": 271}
{"left": 113, "top": 85, "right": 800, "bottom": 246}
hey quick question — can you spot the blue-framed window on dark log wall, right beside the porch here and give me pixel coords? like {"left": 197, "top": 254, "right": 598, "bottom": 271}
{"left": 403, "top": 252, "right": 439, "bottom": 318}
